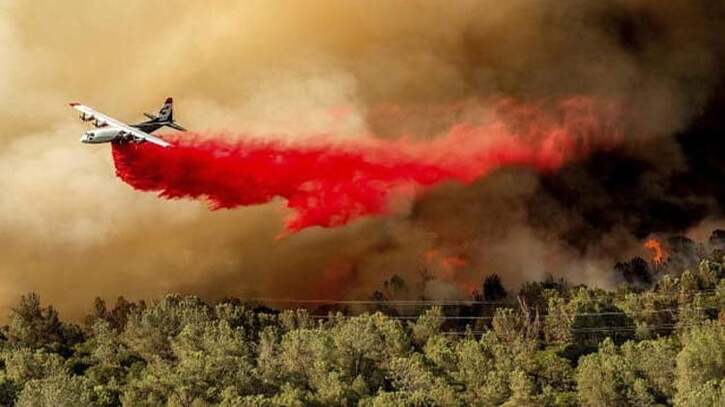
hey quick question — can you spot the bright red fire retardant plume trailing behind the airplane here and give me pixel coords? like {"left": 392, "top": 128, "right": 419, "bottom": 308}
{"left": 113, "top": 98, "right": 618, "bottom": 232}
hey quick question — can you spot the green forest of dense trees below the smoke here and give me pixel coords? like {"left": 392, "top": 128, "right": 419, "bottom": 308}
{"left": 0, "top": 231, "right": 725, "bottom": 407}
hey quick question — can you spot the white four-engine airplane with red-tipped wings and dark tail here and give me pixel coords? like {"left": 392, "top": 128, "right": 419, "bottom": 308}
{"left": 69, "top": 98, "right": 186, "bottom": 147}
